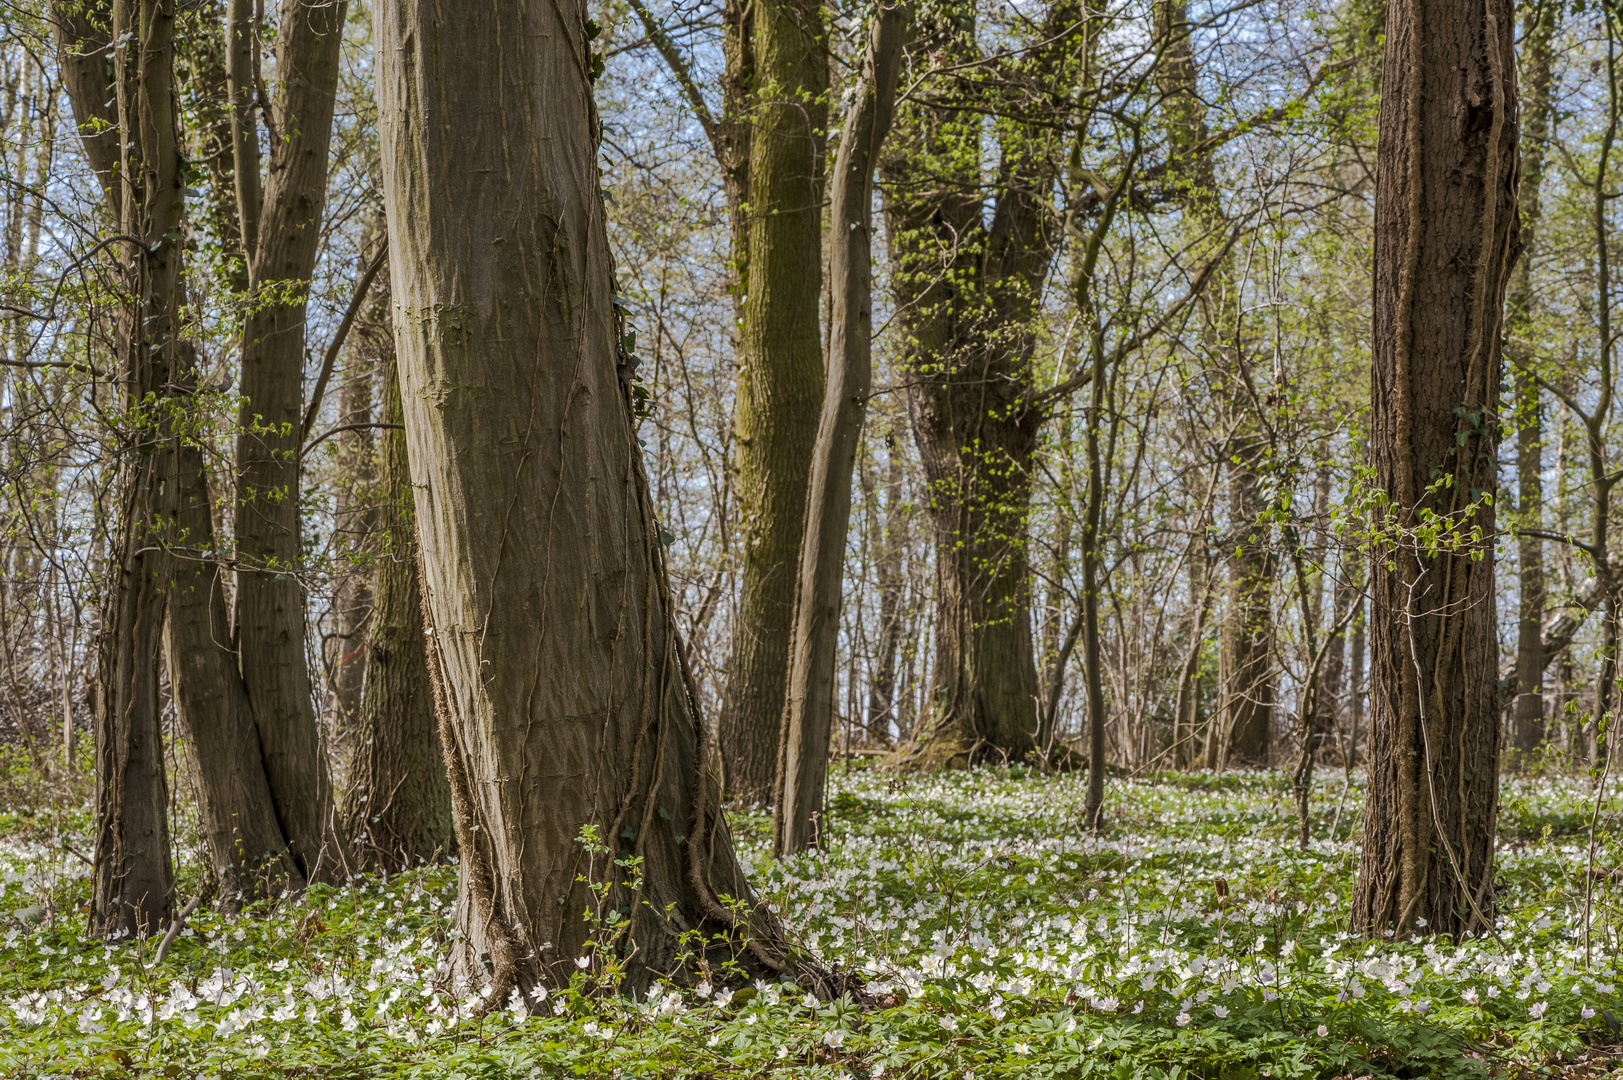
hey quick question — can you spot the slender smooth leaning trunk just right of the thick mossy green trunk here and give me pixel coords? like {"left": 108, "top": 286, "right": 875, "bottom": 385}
{"left": 773, "top": 5, "right": 907, "bottom": 854}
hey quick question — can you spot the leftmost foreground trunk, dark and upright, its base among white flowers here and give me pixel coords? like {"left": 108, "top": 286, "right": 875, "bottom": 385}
{"left": 70, "top": 0, "right": 185, "bottom": 937}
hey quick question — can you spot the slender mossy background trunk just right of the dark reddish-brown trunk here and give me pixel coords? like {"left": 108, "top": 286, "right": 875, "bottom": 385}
{"left": 1505, "top": 3, "right": 1556, "bottom": 756}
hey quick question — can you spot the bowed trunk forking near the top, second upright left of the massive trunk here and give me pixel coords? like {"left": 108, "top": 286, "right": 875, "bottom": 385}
{"left": 232, "top": 0, "right": 347, "bottom": 880}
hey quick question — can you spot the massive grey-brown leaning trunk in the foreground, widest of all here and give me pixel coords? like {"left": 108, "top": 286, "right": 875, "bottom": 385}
{"left": 375, "top": 0, "right": 784, "bottom": 1004}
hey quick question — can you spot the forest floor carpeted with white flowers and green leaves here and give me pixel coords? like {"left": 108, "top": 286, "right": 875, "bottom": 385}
{"left": 0, "top": 753, "right": 1623, "bottom": 1080}
